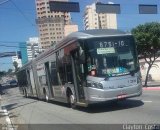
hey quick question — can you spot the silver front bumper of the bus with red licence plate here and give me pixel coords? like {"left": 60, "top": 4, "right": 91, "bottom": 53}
{"left": 85, "top": 84, "right": 142, "bottom": 104}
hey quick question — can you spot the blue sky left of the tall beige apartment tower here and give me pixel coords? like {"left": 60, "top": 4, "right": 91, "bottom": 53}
{"left": 0, "top": 0, "right": 38, "bottom": 71}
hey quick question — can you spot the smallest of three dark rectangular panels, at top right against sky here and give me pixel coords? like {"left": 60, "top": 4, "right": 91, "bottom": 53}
{"left": 139, "top": 5, "right": 158, "bottom": 14}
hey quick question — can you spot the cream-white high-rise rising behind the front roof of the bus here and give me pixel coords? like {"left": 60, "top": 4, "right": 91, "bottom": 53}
{"left": 83, "top": 3, "right": 117, "bottom": 30}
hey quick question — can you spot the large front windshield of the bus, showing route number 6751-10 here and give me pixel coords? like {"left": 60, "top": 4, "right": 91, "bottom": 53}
{"left": 86, "top": 36, "right": 138, "bottom": 77}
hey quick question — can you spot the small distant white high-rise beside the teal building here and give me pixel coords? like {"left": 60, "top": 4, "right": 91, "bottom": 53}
{"left": 27, "top": 37, "right": 42, "bottom": 61}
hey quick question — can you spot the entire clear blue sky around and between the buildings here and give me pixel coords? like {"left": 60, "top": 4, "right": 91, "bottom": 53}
{"left": 0, "top": 0, "right": 160, "bottom": 71}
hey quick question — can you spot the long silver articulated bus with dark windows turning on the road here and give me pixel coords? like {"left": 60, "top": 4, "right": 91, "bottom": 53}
{"left": 17, "top": 29, "right": 142, "bottom": 107}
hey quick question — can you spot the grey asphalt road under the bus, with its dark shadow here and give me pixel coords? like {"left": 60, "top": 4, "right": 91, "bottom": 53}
{"left": 1, "top": 88, "right": 160, "bottom": 130}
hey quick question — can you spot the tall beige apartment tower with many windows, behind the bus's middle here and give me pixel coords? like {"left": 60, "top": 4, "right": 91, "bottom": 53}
{"left": 36, "top": 0, "right": 71, "bottom": 49}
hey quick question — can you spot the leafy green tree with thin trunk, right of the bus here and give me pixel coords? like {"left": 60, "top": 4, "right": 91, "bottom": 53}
{"left": 132, "top": 22, "right": 160, "bottom": 86}
